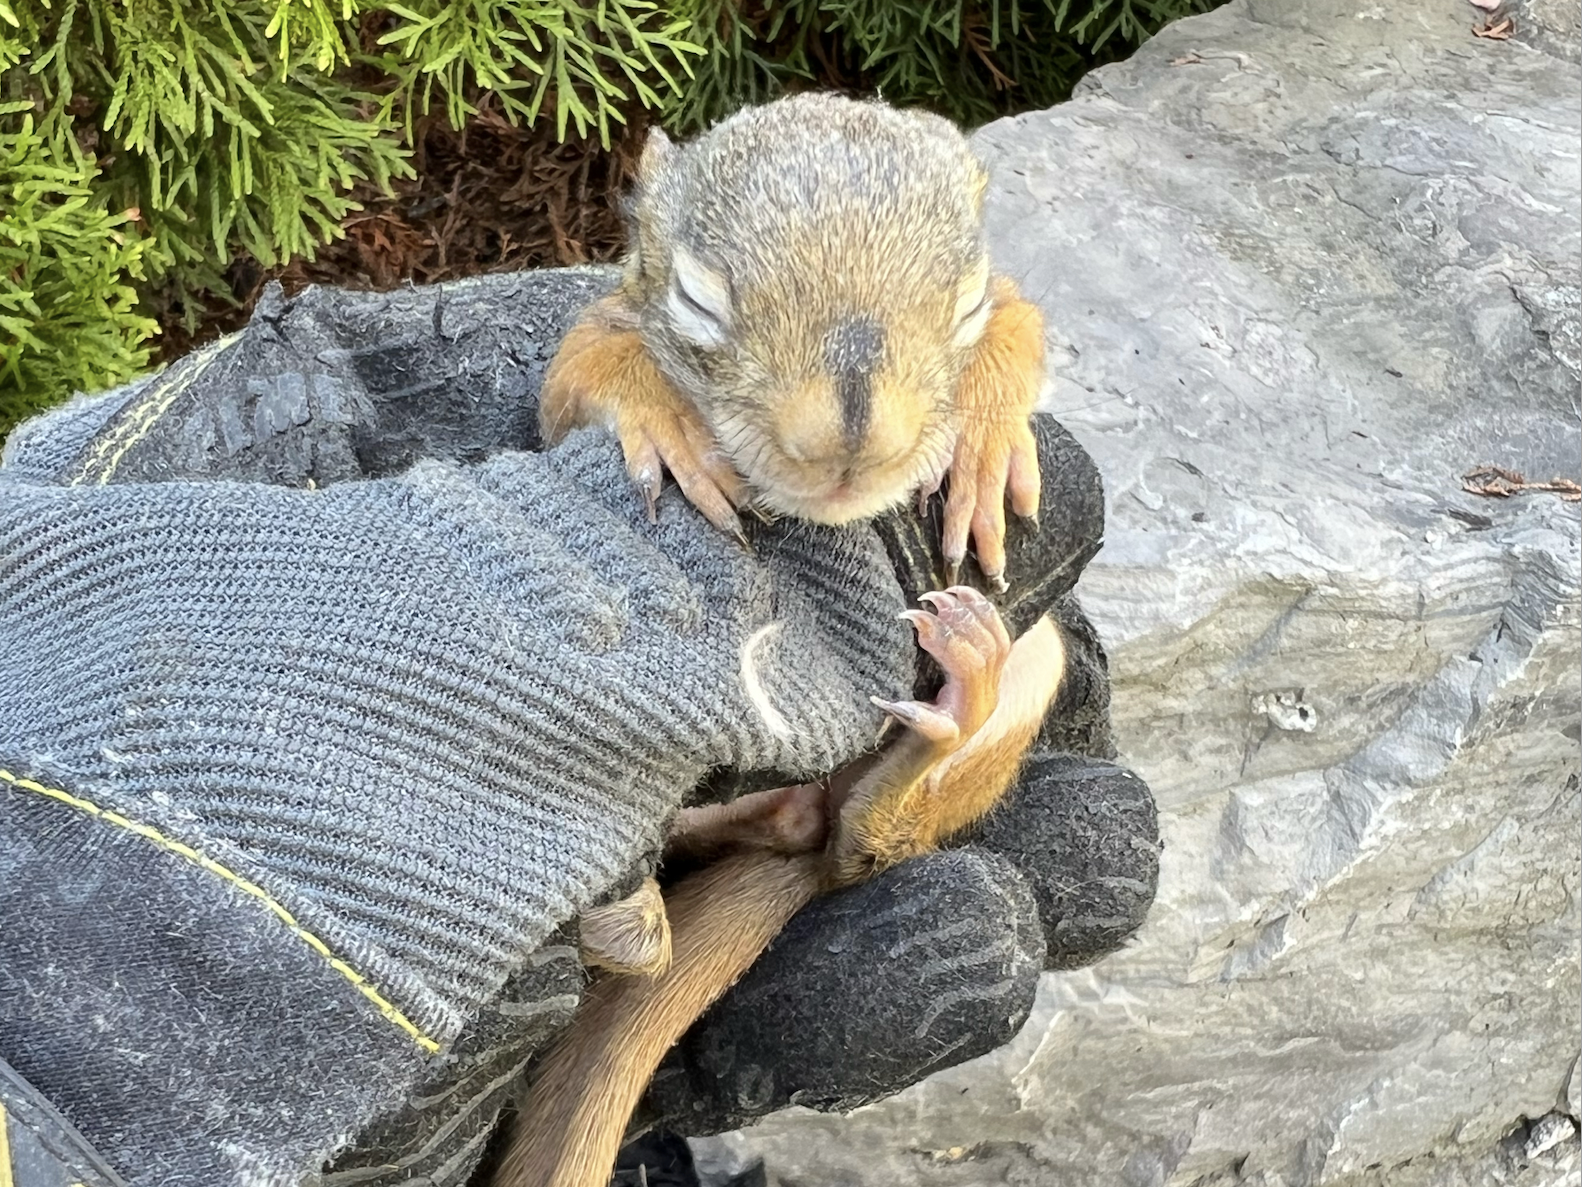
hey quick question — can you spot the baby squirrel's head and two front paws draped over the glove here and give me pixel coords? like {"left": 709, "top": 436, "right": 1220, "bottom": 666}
{"left": 539, "top": 93, "right": 1044, "bottom": 587}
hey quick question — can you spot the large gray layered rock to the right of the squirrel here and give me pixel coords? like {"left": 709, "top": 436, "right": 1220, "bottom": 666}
{"left": 699, "top": 0, "right": 1582, "bottom": 1187}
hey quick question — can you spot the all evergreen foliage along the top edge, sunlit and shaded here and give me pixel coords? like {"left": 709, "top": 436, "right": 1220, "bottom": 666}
{"left": 0, "top": 0, "right": 1220, "bottom": 443}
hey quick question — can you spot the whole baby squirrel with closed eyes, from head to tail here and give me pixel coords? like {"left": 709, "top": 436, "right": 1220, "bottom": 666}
{"left": 494, "top": 93, "right": 1065, "bottom": 1187}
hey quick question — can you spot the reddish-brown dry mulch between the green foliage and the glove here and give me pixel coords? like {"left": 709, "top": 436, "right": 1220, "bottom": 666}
{"left": 158, "top": 97, "right": 647, "bottom": 361}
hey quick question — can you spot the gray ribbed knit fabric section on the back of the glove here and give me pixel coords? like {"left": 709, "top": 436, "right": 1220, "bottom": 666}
{"left": 0, "top": 434, "right": 911, "bottom": 1045}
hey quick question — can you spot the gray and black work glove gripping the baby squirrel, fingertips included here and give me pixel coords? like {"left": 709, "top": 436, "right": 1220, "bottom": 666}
{"left": 0, "top": 271, "right": 1156, "bottom": 1187}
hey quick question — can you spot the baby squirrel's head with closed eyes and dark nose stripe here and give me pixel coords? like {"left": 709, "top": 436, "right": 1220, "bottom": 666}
{"left": 626, "top": 93, "right": 989, "bottom": 524}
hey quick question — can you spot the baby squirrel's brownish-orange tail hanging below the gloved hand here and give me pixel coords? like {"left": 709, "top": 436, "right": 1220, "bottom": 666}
{"left": 494, "top": 851, "right": 823, "bottom": 1187}
